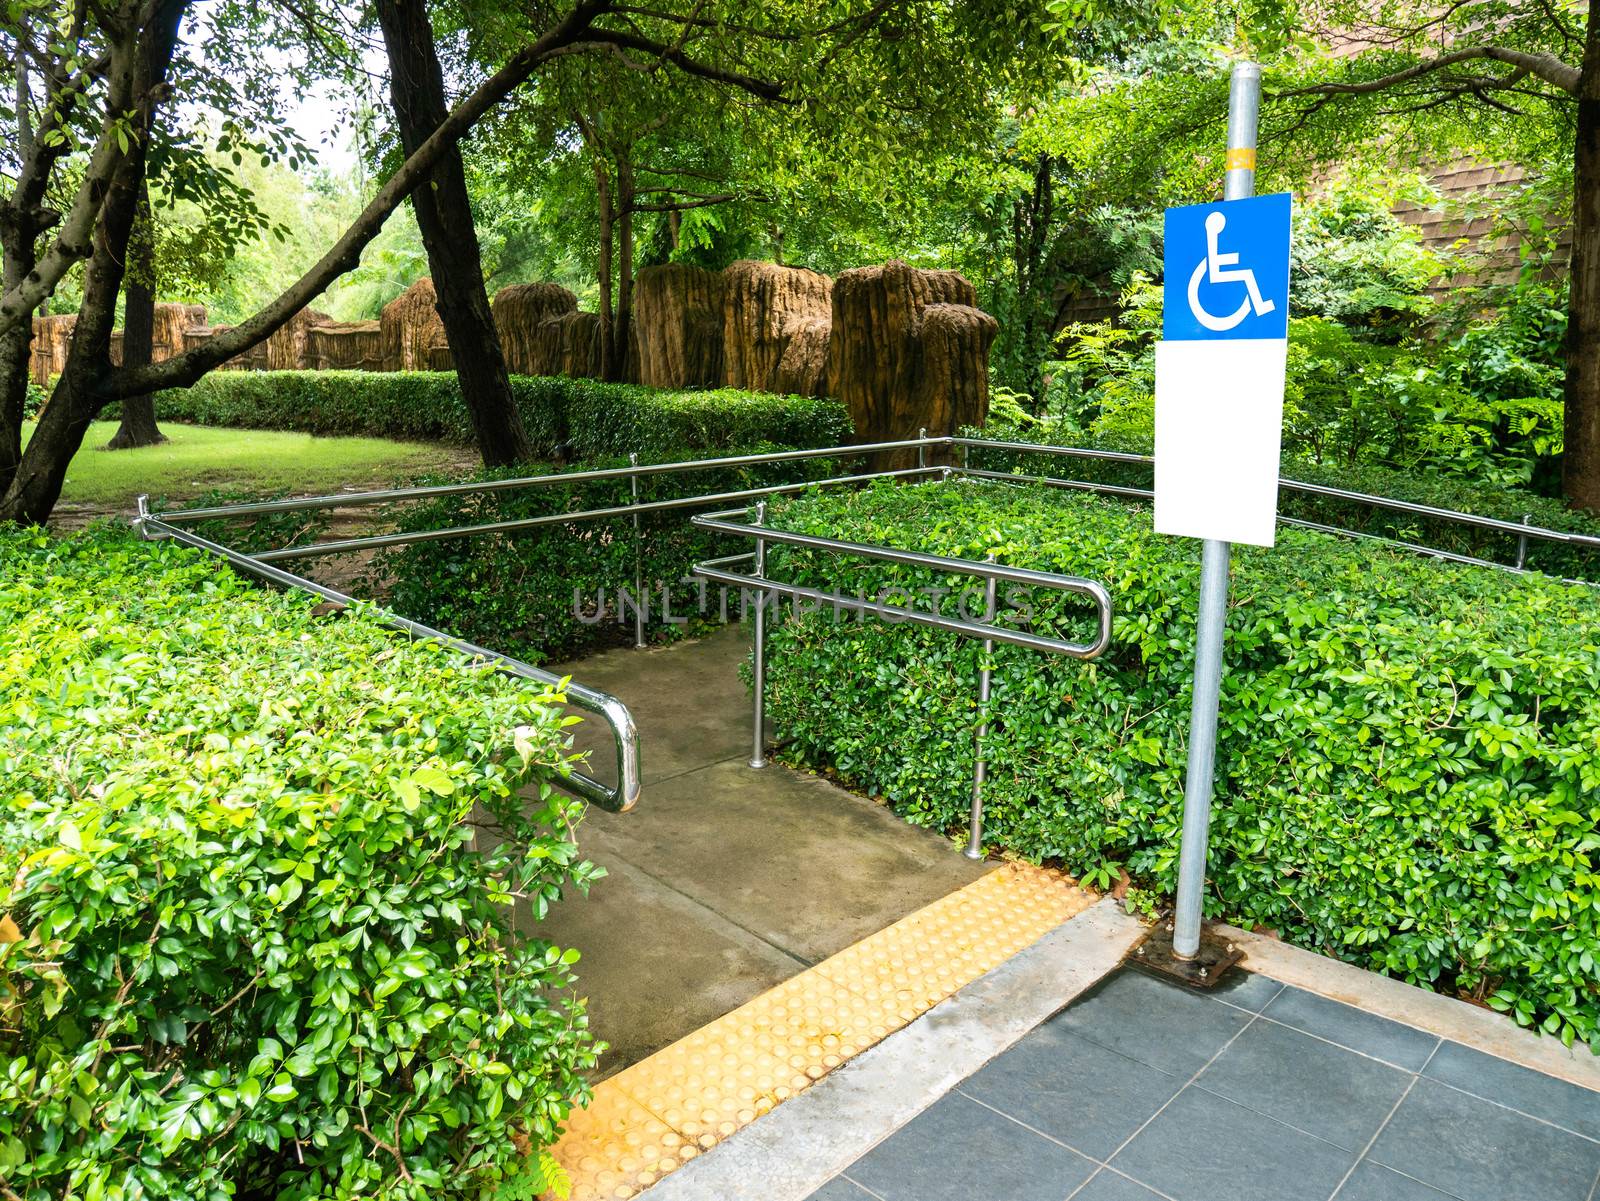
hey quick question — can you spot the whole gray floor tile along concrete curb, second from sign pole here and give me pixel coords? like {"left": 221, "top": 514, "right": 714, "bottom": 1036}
{"left": 962, "top": 1025, "right": 1184, "bottom": 1159}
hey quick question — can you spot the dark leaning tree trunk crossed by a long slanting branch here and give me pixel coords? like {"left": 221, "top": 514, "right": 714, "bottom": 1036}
{"left": 378, "top": 0, "right": 533, "bottom": 467}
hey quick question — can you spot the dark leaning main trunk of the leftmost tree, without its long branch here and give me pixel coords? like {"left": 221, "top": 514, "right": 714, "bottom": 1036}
{"left": 0, "top": 5, "right": 182, "bottom": 525}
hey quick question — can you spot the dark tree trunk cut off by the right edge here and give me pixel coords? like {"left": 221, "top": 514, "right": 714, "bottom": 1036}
{"left": 1562, "top": 3, "right": 1600, "bottom": 513}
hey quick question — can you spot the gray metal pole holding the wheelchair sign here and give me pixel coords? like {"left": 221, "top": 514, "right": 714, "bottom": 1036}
{"left": 1173, "top": 62, "right": 1261, "bottom": 960}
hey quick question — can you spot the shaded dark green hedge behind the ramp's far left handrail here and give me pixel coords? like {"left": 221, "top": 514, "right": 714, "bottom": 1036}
{"left": 366, "top": 446, "right": 840, "bottom": 662}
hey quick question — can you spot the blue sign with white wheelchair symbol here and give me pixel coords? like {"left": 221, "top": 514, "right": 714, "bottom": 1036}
{"left": 1162, "top": 192, "right": 1290, "bottom": 342}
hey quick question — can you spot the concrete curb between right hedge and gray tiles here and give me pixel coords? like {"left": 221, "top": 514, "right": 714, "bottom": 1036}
{"left": 1214, "top": 924, "right": 1600, "bottom": 1091}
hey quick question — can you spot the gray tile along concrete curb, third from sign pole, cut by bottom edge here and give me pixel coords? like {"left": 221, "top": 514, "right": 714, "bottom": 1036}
{"left": 848, "top": 1092, "right": 1094, "bottom": 1201}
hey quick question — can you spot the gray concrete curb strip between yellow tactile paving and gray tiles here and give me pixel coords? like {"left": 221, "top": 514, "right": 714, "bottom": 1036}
{"left": 636, "top": 897, "right": 1144, "bottom": 1201}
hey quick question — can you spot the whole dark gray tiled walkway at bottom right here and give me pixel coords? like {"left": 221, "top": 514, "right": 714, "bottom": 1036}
{"left": 811, "top": 969, "right": 1600, "bottom": 1201}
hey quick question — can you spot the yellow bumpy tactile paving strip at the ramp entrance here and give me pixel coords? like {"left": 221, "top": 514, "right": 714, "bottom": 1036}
{"left": 552, "top": 864, "right": 1094, "bottom": 1201}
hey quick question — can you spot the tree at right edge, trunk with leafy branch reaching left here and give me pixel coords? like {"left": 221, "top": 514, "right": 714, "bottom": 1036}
{"left": 1267, "top": 0, "right": 1600, "bottom": 512}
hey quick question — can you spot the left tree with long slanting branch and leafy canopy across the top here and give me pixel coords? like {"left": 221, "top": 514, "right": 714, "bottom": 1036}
{"left": 0, "top": 0, "right": 1139, "bottom": 521}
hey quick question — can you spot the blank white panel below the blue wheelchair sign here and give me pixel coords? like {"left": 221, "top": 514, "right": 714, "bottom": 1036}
{"left": 1155, "top": 337, "right": 1288, "bottom": 547}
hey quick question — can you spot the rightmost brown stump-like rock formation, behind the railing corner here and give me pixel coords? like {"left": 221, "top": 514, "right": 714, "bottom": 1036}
{"left": 827, "top": 259, "right": 998, "bottom": 465}
